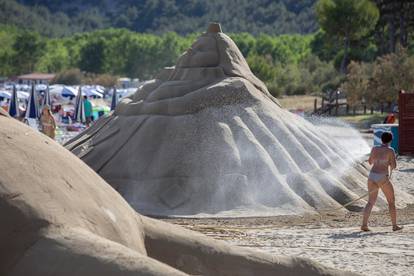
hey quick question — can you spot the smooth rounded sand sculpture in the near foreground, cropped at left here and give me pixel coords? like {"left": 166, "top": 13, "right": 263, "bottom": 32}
{"left": 0, "top": 116, "right": 358, "bottom": 276}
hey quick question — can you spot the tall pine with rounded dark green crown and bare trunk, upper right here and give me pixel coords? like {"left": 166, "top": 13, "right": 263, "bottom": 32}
{"left": 316, "top": 0, "right": 379, "bottom": 73}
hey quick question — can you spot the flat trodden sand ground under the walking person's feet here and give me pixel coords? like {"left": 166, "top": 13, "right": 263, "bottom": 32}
{"left": 164, "top": 156, "right": 414, "bottom": 276}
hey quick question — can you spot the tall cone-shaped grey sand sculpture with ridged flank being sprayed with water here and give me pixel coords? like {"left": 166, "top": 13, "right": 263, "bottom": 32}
{"left": 66, "top": 24, "right": 411, "bottom": 215}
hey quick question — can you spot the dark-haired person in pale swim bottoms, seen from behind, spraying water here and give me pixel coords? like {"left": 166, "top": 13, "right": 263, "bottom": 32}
{"left": 361, "top": 132, "right": 402, "bottom": 231}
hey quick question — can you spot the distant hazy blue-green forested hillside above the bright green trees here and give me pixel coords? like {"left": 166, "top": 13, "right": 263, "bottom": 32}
{"left": 0, "top": 0, "right": 318, "bottom": 36}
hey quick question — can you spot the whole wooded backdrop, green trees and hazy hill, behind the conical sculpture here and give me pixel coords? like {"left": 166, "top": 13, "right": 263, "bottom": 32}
{"left": 0, "top": 0, "right": 414, "bottom": 107}
